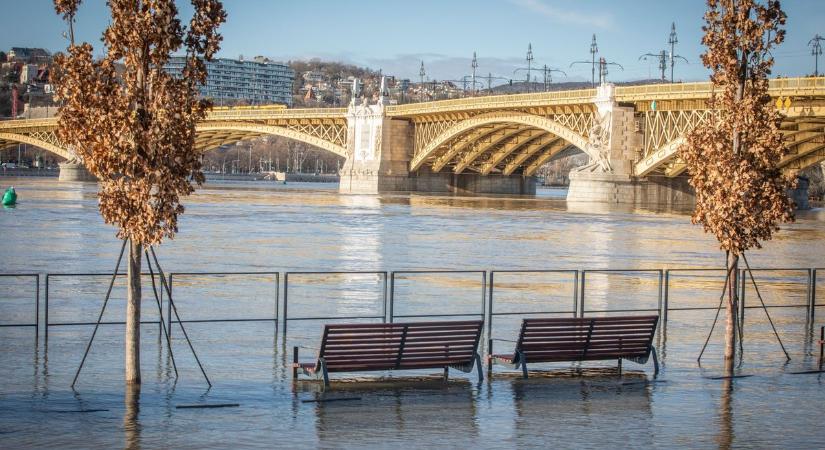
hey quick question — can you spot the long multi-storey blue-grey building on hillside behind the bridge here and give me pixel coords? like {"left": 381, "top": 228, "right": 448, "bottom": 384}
{"left": 164, "top": 57, "right": 295, "bottom": 106}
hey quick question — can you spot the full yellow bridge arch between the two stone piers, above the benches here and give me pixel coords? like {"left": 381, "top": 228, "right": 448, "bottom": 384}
{"left": 410, "top": 111, "right": 588, "bottom": 176}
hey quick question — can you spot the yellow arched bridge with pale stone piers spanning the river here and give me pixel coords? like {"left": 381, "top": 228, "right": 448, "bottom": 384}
{"left": 0, "top": 77, "right": 825, "bottom": 201}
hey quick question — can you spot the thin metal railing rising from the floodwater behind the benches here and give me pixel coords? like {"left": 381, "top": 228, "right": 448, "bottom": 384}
{"left": 0, "top": 268, "right": 825, "bottom": 337}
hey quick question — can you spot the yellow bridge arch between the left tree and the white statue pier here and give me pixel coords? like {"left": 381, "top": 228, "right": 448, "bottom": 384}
{"left": 195, "top": 123, "right": 348, "bottom": 158}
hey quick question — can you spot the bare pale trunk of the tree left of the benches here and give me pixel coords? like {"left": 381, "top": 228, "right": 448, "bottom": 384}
{"left": 125, "top": 239, "right": 143, "bottom": 384}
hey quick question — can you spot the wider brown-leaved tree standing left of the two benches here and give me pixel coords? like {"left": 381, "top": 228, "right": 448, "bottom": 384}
{"left": 53, "top": 0, "right": 226, "bottom": 384}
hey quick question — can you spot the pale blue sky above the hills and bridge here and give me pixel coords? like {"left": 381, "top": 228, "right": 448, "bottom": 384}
{"left": 0, "top": 0, "right": 825, "bottom": 81}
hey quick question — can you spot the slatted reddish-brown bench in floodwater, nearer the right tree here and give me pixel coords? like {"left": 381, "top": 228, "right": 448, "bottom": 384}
{"left": 487, "top": 316, "right": 659, "bottom": 378}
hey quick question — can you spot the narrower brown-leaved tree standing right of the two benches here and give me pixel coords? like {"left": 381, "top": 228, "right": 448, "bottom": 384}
{"left": 682, "top": 0, "right": 794, "bottom": 374}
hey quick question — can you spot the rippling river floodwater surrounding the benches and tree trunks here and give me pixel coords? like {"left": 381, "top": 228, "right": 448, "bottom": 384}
{"left": 0, "top": 178, "right": 825, "bottom": 448}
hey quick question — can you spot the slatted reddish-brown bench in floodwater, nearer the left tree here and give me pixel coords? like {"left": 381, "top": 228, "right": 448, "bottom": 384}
{"left": 292, "top": 320, "right": 483, "bottom": 386}
